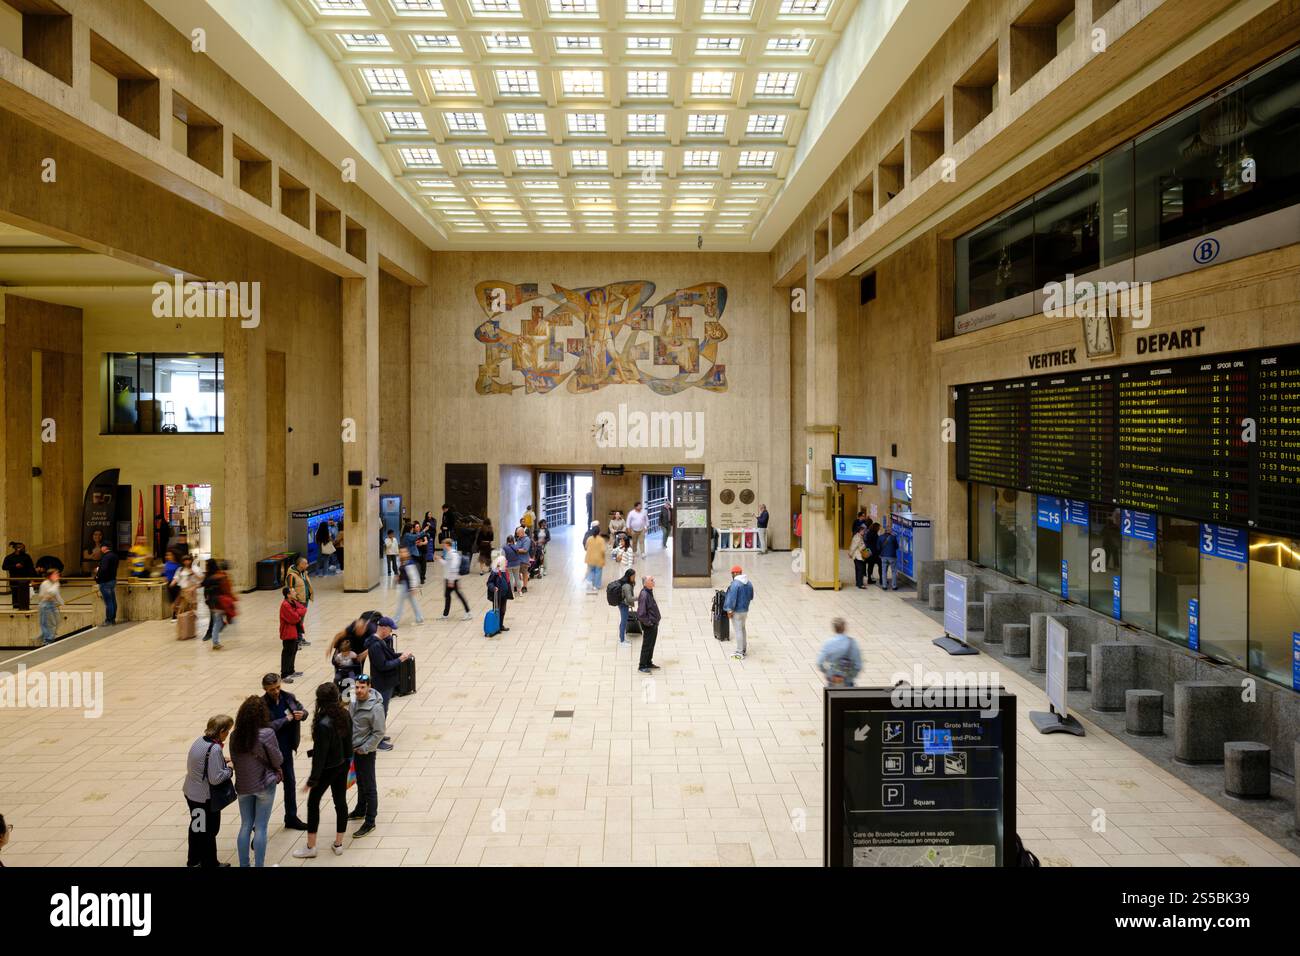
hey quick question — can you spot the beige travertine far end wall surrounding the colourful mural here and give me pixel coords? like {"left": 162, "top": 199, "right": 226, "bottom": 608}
{"left": 426, "top": 252, "right": 789, "bottom": 546}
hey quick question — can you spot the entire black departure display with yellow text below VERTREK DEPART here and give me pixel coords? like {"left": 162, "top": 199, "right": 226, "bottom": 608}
{"left": 956, "top": 346, "right": 1300, "bottom": 537}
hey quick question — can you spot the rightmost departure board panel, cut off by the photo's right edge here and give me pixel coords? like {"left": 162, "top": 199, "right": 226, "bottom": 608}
{"left": 1251, "top": 347, "right": 1300, "bottom": 537}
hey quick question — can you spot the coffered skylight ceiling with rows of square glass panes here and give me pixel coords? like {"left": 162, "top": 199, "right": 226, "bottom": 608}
{"left": 285, "top": 0, "right": 858, "bottom": 242}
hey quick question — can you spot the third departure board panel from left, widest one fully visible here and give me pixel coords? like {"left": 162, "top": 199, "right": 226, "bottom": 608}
{"left": 1115, "top": 355, "right": 1251, "bottom": 525}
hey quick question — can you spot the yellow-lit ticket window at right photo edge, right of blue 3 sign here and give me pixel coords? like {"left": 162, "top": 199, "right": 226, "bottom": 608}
{"left": 1248, "top": 535, "right": 1300, "bottom": 687}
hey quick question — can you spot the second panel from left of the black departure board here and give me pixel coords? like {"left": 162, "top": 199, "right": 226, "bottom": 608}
{"left": 1028, "top": 371, "right": 1115, "bottom": 502}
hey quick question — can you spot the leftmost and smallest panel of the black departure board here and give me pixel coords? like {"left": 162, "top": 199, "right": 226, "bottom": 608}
{"left": 958, "top": 381, "right": 1030, "bottom": 489}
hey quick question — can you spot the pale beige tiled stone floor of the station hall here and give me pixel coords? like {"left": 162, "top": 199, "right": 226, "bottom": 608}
{"left": 0, "top": 535, "right": 1297, "bottom": 866}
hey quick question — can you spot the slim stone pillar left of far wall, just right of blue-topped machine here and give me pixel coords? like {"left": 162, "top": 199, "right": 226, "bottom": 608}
{"left": 341, "top": 243, "right": 379, "bottom": 591}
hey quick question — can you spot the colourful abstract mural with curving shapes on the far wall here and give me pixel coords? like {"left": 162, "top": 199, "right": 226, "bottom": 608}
{"left": 475, "top": 280, "right": 727, "bottom": 395}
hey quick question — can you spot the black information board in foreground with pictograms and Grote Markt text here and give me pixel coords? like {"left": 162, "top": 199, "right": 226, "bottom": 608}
{"left": 823, "top": 685, "right": 1015, "bottom": 866}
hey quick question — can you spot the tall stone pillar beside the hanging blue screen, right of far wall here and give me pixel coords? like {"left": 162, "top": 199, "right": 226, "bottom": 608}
{"left": 803, "top": 264, "right": 840, "bottom": 589}
